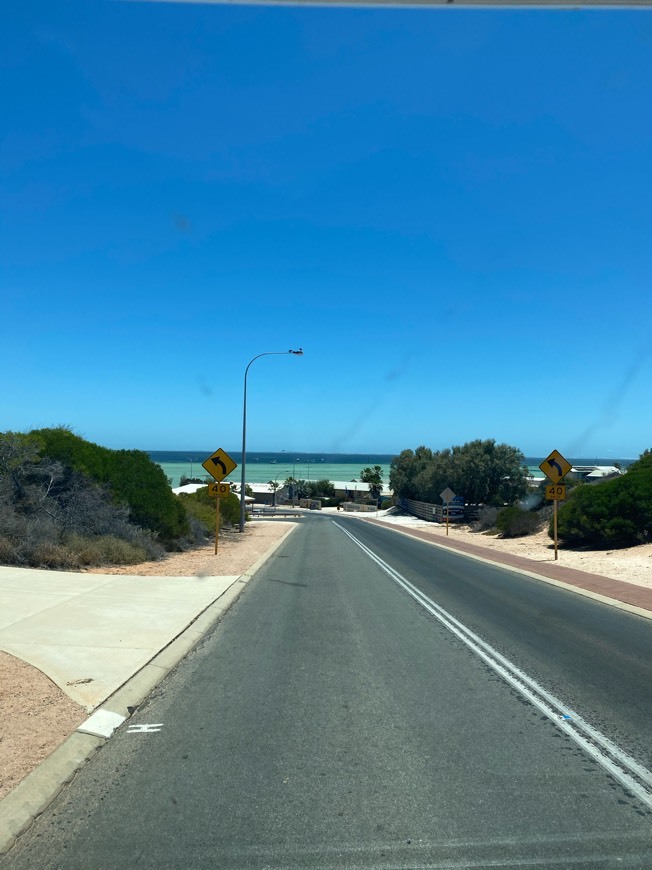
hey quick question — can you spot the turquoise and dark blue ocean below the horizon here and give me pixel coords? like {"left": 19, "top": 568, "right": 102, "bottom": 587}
{"left": 148, "top": 449, "right": 633, "bottom": 486}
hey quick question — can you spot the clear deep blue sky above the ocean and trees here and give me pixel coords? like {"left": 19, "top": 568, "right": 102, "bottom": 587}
{"left": 0, "top": 0, "right": 652, "bottom": 458}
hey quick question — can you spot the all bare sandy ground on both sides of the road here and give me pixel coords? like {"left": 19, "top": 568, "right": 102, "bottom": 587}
{"left": 0, "top": 511, "right": 652, "bottom": 798}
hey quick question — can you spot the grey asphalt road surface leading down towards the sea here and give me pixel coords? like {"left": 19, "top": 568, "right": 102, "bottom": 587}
{"left": 5, "top": 517, "right": 652, "bottom": 870}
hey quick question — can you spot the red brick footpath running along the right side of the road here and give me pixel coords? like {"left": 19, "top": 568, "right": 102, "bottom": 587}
{"left": 365, "top": 518, "right": 652, "bottom": 614}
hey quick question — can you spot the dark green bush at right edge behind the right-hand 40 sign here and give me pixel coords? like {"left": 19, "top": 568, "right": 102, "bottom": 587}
{"left": 550, "top": 453, "right": 652, "bottom": 549}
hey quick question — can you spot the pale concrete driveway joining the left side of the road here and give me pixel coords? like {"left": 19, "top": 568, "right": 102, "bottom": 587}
{"left": 0, "top": 567, "right": 238, "bottom": 711}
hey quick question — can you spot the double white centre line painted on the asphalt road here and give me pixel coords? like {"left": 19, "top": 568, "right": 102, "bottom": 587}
{"left": 332, "top": 520, "right": 652, "bottom": 809}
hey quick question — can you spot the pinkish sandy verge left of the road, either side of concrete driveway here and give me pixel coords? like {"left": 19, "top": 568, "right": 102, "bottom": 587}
{"left": 0, "top": 520, "right": 290, "bottom": 799}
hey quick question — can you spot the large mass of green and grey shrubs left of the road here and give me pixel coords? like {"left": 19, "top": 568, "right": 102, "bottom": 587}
{"left": 0, "top": 426, "right": 239, "bottom": 570}
